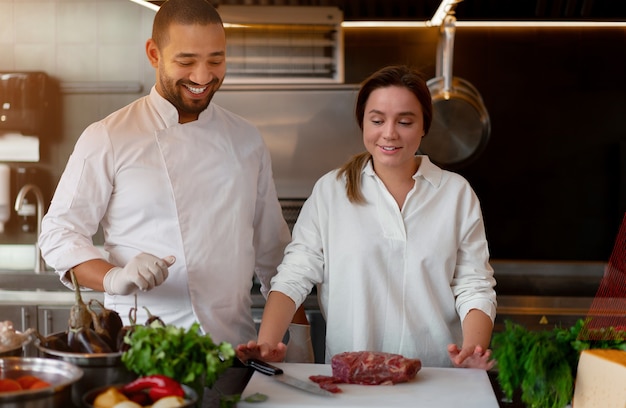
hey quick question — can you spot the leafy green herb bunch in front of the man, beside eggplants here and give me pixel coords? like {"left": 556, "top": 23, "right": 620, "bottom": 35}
{"left": 122, "top": 321, "right": 235, "bottom": 389}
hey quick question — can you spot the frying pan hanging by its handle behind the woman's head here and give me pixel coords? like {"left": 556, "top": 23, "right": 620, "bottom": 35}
{"left": 420, "top": 15, "right": 491, "bottom": 168}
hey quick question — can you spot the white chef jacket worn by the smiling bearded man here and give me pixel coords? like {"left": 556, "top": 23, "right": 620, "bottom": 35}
{"left": 39, "top": 87, "right": 290, "bottom": 344}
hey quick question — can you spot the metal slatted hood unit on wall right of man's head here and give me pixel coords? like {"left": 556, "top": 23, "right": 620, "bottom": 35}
{"left": 131, "top": 0, "right": 344, "bottom": 85}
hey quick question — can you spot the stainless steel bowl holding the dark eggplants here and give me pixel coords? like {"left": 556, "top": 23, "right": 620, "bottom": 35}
{"left": 35, "top": 332, "right": 137, "bottom": 406}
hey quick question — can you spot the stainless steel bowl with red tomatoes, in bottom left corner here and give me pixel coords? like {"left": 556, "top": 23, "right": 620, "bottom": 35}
{"left": 0, "top": 357, "right": 83, "bottom": 408}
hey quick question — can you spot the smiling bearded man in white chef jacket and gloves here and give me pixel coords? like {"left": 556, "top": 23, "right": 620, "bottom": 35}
{"left": 39, "top": 0, "right": 308, "bottom": 358}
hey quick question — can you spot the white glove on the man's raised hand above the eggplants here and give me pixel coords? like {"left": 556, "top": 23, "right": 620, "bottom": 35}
{"left": 102, "top": 253, "right": 176, "bottom": 295}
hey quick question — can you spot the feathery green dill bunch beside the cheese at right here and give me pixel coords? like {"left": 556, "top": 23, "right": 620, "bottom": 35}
{"left": 491, "top": 319, "right": 626, "bottom": 408}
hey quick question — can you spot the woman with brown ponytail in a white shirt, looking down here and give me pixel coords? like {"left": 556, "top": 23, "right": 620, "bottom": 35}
{"left": 237, "top": 66, "right": 496, "bottom": 369}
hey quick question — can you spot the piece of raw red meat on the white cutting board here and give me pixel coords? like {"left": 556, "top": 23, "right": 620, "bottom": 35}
{"left": 309, "top": 351, "right": 422, "bottom": 392}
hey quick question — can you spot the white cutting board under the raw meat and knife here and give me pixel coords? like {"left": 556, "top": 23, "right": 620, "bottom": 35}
{"left": 237, "top": 363, "right": 498, "bottom": 408}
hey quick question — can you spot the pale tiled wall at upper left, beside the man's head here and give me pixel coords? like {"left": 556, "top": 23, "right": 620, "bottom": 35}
{"left": 0, "top": 0, "right": 154, "bottom": 82}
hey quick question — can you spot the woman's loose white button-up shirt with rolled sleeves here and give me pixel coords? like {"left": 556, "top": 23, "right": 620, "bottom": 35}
{"left": 271, "top": 156, "right": 496, "bottom": 367}
